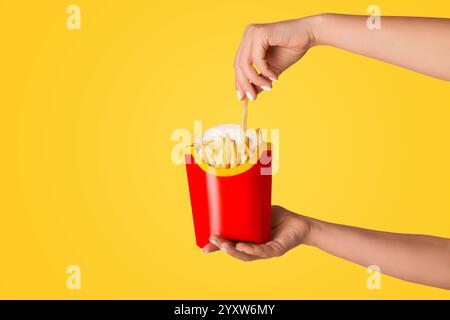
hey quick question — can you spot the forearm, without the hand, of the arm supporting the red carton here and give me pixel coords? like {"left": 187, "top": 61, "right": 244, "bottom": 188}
{"left": 306, "top": 218, "right": 450, "bottom": 289}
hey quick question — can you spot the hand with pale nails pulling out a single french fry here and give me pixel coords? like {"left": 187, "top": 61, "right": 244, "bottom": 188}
{"left": 234, "top": 17, "right": 315, "bottom": 100}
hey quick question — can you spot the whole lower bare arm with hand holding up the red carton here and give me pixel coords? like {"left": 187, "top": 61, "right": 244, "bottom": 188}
{"left": 207, "top": 206, "right": 450, "bottom": 290}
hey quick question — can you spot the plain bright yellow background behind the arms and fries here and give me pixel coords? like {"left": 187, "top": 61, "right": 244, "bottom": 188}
{"left": 0, "top": 0, "right": 450, "bottom": 299}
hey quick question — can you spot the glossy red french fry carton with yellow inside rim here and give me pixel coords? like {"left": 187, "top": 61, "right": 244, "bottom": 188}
{"left": 185, "top": 143, "right": 272, "bottom": 248}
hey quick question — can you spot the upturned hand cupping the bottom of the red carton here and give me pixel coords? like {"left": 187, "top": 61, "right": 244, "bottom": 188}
{"left": 203, "top": 206, "right": 311, "bottom": 261}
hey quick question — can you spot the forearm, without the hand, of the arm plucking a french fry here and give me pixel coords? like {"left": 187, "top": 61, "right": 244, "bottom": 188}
{"left": 310, "top": 14, "right": 450, "bottom": 80}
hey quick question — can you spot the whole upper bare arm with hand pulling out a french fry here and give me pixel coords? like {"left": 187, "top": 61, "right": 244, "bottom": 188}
{"left": 234, "top": 14, "right": 450, "bottom": 100}
